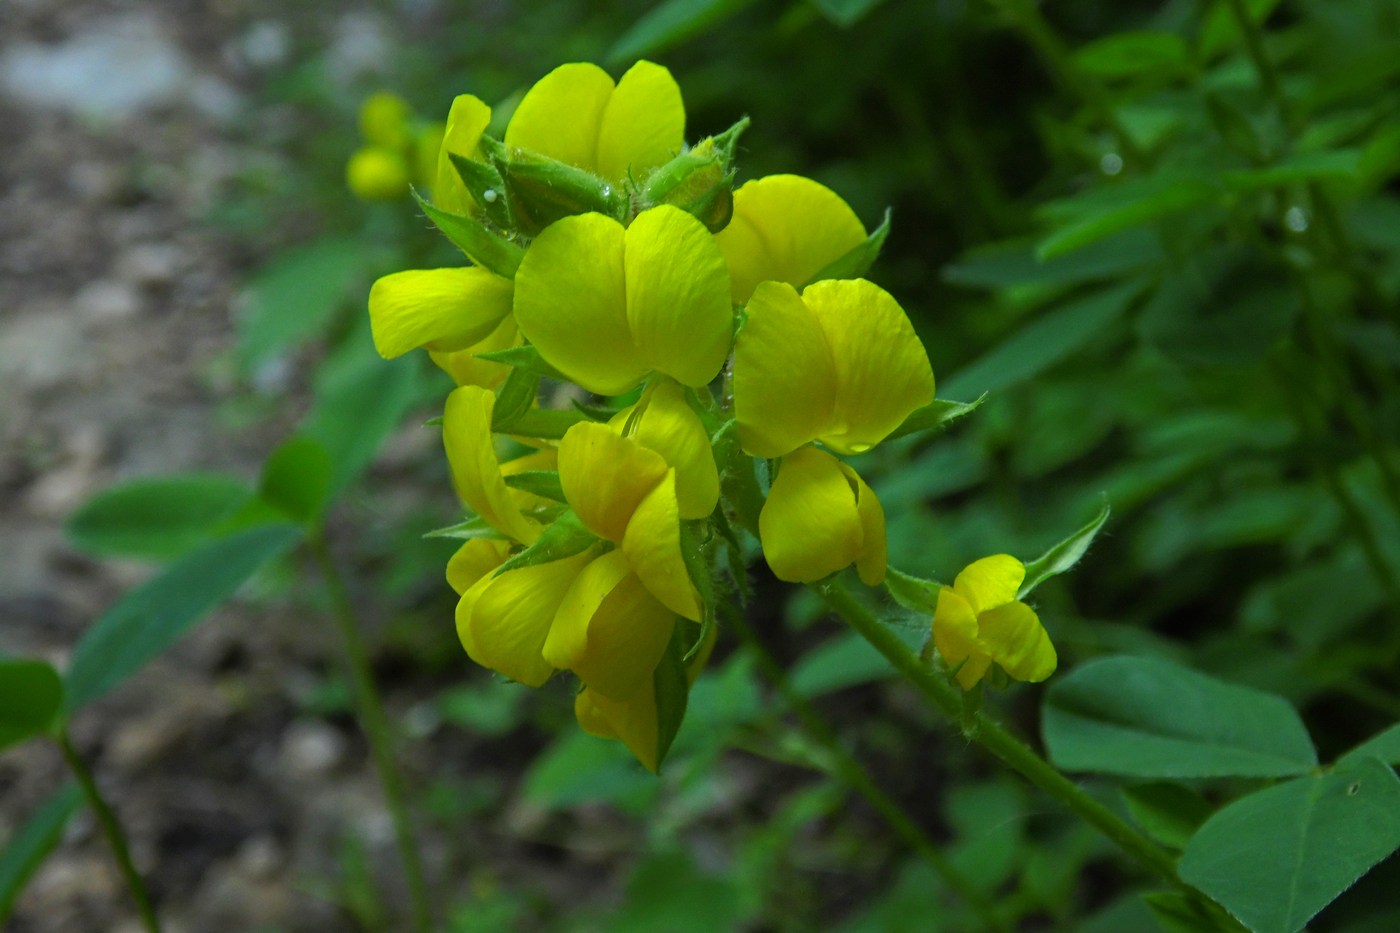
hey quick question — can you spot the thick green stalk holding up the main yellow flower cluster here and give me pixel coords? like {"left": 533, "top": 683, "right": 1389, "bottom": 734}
{"left": 813, "top": 580, "right": 1181, "bottom": 897}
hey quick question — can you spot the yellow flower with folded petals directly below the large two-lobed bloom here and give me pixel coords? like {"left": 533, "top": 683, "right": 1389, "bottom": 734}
{"left": 559, "top": 388, "right": 718, "bottom": 622}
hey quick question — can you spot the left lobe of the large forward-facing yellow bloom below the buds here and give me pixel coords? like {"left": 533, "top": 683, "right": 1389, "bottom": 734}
{"left": 515, "top": 214, "right": 651, "bottom": 395}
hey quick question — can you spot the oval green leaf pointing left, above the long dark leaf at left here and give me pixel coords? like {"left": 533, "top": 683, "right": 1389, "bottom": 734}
{"left": 64, "top": 474, "right": 252, "bottom": 560}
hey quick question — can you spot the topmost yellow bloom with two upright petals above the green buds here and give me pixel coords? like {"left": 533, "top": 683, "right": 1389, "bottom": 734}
{"left": 505, "top": 62, "right": 686, "bottom": 182}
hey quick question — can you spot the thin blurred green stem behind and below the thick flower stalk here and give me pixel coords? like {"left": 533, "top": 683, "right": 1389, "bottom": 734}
{"left": 725, "top": 607, "right": 1011, "bottom": 930}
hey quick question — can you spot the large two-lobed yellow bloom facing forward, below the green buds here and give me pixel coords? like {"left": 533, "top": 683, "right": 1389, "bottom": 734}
{"left": 515, "top": 206, "right": 734, "bottom": 395}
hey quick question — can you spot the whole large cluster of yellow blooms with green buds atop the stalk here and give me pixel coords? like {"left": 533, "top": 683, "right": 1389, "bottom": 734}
{"left": 370, "top": 62, "right": 1030, "bottom": 770}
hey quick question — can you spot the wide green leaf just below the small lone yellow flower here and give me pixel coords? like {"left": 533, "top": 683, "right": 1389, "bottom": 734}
{"left": 1042, "top": 656, "right": 1317, "bottom": 778}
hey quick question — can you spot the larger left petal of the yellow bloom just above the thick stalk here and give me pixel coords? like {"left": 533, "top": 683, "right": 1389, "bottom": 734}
{"left": 759, "top": 447, "right": 865, "bottom": 583}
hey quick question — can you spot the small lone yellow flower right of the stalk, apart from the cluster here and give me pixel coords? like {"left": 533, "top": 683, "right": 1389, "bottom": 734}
{"left": 932, "top": 553, "right": 1057, "bottom": 689}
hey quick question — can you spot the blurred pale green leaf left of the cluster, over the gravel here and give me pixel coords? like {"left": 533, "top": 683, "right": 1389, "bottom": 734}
{"left": 238, "top": 235, "right": 365, "bottom": 366}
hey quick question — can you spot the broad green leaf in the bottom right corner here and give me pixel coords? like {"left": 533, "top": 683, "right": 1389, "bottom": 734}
{"left": 1179, "top": 758, "right": 1400, "bottom": 933}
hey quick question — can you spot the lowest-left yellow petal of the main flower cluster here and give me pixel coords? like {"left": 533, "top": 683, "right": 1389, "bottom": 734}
{"left": 456, "top": 551, "right": 591, "bottom": 686}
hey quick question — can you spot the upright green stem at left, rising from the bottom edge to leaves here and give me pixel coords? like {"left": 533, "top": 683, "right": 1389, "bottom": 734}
{"left": 307, "top": 532, "right": 433, "bottom": 933}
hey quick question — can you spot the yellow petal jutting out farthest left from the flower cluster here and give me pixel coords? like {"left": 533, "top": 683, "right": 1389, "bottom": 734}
{"left": 370, "top": 266, "right": 514, "bottom": 359}
